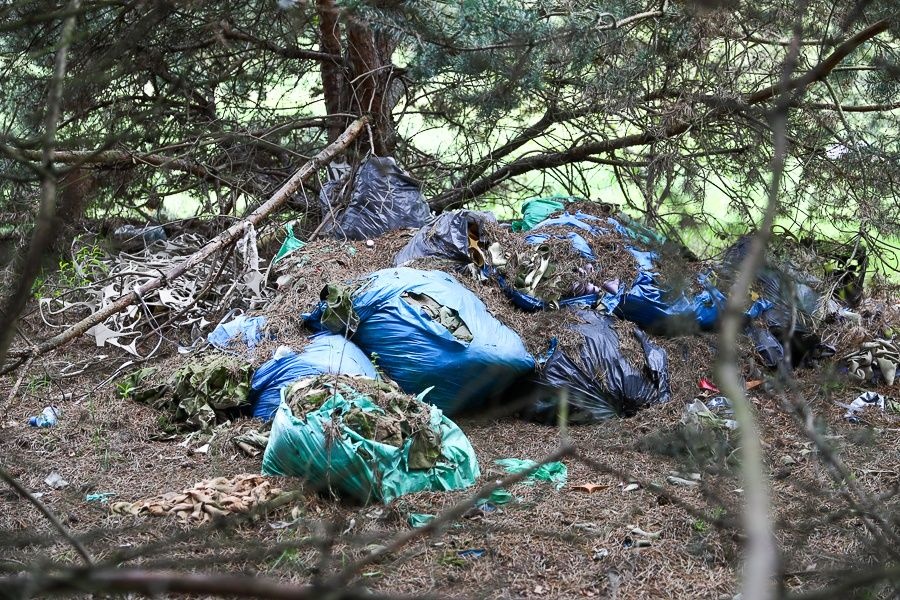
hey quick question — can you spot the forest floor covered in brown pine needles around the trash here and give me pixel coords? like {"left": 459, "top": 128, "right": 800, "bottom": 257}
{"left": 0, "top": 226, "right": 900, "bottom": 599}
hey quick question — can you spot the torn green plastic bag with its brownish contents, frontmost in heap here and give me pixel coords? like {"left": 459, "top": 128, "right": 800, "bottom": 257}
{"left": 262, "top": 375, "right": 480, "bottom": 504}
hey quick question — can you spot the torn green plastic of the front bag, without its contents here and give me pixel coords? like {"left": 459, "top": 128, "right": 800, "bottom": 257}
{"left": 262, "top": 380, "right": 480, "bottom": 504}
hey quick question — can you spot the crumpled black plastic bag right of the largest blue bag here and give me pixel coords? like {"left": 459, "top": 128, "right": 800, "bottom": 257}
{"left": 524, "top": 311, "right": 670, "bottom": 424}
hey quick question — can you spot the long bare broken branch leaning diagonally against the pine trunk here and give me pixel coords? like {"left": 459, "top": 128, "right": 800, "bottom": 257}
{"left": 2, "top": 117, "right": 367, "bottom": 373}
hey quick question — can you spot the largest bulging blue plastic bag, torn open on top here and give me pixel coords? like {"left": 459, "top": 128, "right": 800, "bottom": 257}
{"left": 307, "top": 267, "right": 534, "bottom": 415}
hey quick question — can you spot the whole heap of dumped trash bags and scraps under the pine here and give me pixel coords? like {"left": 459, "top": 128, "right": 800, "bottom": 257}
{"left": 118, "top": 159, "right": 884, "bottom": 502}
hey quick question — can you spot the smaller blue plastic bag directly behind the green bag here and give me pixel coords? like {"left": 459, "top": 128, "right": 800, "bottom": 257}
{"left": 250, "top": 334, "right": 377, "bottom": 421}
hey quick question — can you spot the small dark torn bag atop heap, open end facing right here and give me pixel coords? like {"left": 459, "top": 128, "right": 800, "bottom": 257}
{"left": 394, "top": 210, "right": 497, "bottom": 267}
